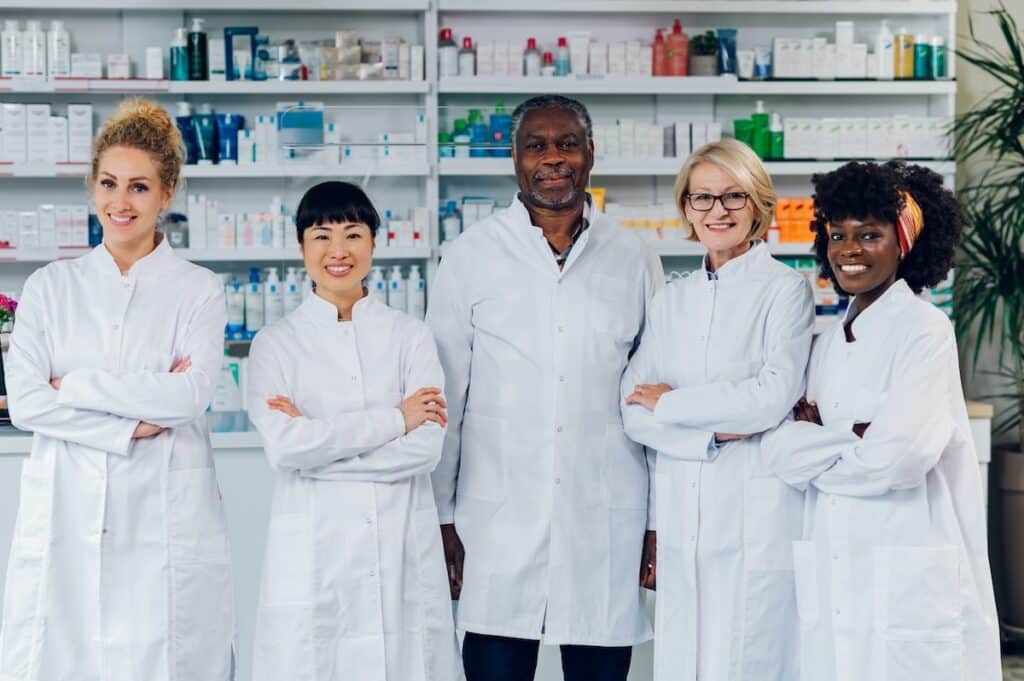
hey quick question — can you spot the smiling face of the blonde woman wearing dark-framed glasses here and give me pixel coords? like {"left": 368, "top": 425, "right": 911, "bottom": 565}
{"left": 683, "top": 163, "right": 755, "bottom": 260}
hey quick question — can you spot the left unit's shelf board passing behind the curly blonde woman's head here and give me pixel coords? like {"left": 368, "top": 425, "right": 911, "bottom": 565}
{"left": 0, "top": 161, "right": 430, "bottom": 179}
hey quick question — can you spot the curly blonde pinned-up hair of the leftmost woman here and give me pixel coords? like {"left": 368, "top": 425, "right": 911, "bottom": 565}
{"left": 88, "top": 97, "right": 185, "bottom": 190}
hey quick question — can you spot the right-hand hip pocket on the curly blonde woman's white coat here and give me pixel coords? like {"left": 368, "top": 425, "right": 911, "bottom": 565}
{"left": 167, "top": 468, "right": 230, "bottom": 563}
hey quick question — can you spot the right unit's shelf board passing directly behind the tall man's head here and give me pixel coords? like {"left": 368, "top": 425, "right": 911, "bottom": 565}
{"left": 438, "top": 157, "right": 956, "bottom": 177}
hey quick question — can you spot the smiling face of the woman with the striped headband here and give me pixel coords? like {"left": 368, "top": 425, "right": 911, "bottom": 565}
{"left": 827, "top": 217, "right": 900, "bottom": 309}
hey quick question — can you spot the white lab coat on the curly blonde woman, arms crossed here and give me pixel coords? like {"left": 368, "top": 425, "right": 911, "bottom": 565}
{"left": 0, "top": 239, "right": 234, "bottom": 681}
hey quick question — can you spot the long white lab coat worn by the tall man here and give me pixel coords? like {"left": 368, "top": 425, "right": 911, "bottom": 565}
{"left": 427, "top": 199, "right": 663, "bottom": 646}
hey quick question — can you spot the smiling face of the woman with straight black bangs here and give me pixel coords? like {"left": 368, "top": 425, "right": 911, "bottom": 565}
{"left": 300, "top": 222, "right": 374, "bottom": 302}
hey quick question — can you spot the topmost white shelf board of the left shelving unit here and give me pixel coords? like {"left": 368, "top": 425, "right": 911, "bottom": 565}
{"left": 0, "top": 0, "right": 430, "bottom": 12}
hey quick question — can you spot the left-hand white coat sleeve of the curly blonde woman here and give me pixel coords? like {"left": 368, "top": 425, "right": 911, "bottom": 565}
{"left": 6, "top": 271, "right": 138, "bottom": 456}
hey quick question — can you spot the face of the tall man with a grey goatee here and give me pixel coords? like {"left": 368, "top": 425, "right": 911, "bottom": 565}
{"left": 512, "top": 109, "right": 594, "bottom": 210}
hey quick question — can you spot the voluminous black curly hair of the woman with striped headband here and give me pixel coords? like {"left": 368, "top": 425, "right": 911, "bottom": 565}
{"left": 811, "top": 161, "right": 964, "bottom": 293}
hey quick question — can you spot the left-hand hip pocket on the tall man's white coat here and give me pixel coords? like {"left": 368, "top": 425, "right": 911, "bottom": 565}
{"left": 456, "top": 412, "right": 510, "bottom": 502}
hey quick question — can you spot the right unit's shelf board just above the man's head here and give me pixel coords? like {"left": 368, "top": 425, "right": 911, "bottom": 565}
{"left": 438, "top": 75, "right": 956, "bottom": 96}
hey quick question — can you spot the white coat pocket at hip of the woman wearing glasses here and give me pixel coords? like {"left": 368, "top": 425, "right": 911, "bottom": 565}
{"left": 743, "top": 477, "right": 804, "bottom": 570}
